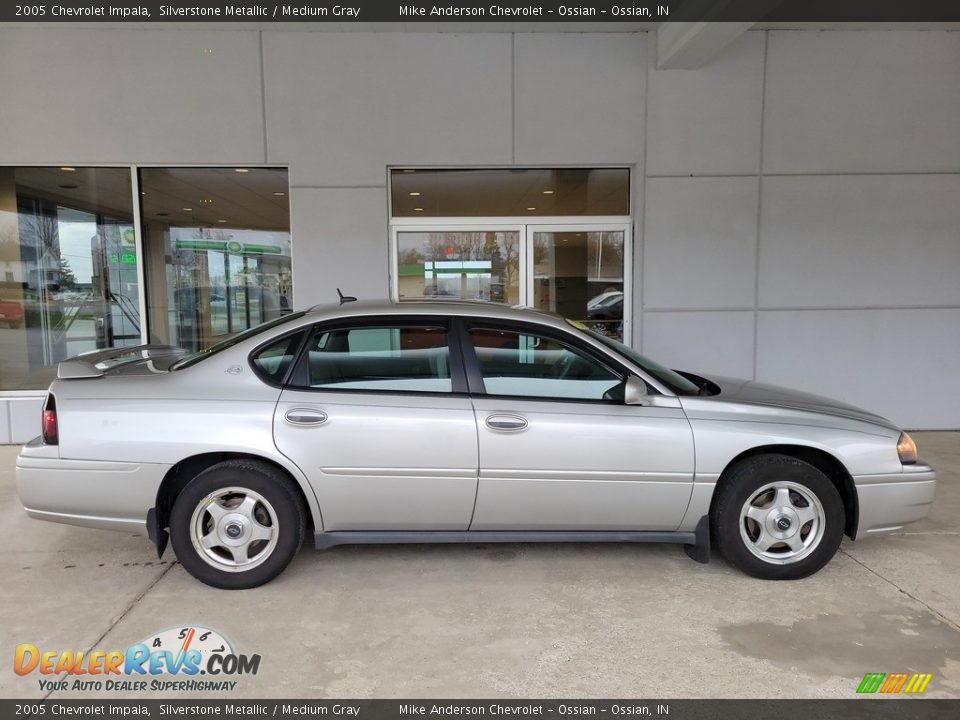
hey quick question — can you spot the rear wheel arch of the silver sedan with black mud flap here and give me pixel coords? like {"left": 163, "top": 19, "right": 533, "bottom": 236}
{"left": 147, "top": 451, "right": 323, "bottom": 555}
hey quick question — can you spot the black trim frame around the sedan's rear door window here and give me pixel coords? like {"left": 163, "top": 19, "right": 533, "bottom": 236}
{"left": 283, "top": 315, "right": 469, "bottom": 397}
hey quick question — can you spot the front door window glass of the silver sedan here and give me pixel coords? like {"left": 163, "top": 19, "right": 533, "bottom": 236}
{"left": 470, "top": 328, "right": 621, "bottom": 400}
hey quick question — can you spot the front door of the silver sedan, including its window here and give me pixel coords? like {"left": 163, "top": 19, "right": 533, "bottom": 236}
{"left": 464, "top": 322, "right": 694, "bottom": 530}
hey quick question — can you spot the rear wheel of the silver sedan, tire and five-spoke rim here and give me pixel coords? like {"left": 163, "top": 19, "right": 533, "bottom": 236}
{"left": 170, "top": 460, "right": 306, "bottom": 590}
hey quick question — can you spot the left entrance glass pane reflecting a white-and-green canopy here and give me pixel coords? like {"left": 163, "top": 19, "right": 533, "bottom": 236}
{"left": 397, "top": 229, "right": 520, "bottom": 305}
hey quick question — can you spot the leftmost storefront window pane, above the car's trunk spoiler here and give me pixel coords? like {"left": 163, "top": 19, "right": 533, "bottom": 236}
{"left": 0, "top": 167, "right": 141, "bottom": 390}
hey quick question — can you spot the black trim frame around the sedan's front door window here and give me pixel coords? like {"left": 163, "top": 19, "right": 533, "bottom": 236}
{"left": 458, "top": 317, "right": 632, "bottom": 406}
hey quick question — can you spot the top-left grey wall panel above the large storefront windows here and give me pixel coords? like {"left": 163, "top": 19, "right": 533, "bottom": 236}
{"left": 0, "top": 27, "right": 264, "bottom": 165}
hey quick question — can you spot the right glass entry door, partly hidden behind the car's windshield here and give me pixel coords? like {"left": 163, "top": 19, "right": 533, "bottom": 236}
{"left": 527, "top": 225, "right": 629, "bottom": 341}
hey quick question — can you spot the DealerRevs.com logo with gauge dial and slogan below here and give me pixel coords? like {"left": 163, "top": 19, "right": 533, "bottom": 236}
{"left": 13, "top": 625, "right": 260, "bottom": 692}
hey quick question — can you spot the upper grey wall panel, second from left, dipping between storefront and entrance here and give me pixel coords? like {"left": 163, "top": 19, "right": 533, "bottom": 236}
{"left": 263, "top": 31, "right": 511, "bottom": 186}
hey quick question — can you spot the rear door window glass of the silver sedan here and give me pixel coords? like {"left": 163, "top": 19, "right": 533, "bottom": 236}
{"left": 307, "top": 326, "right": 453, "bottom": 392}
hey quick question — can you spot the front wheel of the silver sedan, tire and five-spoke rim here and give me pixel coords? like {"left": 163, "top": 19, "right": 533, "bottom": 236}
{"left": 710, "top": 455, "right": 846, "bottom": 580}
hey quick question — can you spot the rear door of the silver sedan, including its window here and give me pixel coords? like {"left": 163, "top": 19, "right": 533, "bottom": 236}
{"left": 273, "top": 318, "right": 478, "bottom": 531}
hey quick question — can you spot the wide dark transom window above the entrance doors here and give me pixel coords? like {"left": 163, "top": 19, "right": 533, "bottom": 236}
{"left": 390, "top": 168, "right": 630, "bottom": 218}
